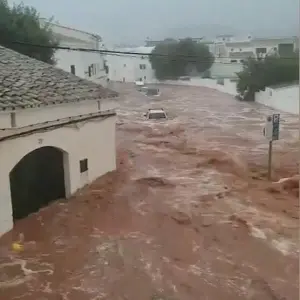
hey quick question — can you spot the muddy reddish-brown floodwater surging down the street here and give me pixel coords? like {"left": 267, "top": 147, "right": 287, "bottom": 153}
{"left": 0, "top": 84, "right": 299, "bottom": 300}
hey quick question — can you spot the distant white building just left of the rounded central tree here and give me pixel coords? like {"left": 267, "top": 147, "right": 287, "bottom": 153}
{"left": 107, "top": 47, "right": 155, "bottom": 83}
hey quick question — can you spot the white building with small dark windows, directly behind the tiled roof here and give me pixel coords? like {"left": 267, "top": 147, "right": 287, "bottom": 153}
{"left": 40, "top": 19, "right": 107, "bottom": 85}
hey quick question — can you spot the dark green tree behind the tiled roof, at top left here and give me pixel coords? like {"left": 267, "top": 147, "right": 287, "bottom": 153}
{"left": 0, "top": 0, "right": 58, "bottom": 64}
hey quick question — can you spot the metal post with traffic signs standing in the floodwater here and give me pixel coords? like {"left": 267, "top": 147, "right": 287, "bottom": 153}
{"left": 264, "top": 114, "right": 280, "bottom": 180}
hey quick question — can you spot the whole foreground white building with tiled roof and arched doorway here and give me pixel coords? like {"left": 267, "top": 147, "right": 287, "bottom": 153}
{"left": 0, "top": 46, "right": 118, "bottom": 235}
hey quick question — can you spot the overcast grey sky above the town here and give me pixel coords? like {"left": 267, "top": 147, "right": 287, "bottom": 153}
{"left": 9, "top": 0, "right": 299, "bottom": 43}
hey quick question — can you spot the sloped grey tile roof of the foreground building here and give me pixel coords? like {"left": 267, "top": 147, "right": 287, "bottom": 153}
{"left": 0, "top": 46, "right": 118, "bottom": 110}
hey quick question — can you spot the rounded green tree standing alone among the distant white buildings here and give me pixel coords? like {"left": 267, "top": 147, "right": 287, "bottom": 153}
{"left": 150, "top": 38, "right": 214, "bottom": 80}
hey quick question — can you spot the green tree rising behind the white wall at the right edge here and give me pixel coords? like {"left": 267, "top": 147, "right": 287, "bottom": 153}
{"left": 237, "top": 51, "right": 299, "bottom": 101}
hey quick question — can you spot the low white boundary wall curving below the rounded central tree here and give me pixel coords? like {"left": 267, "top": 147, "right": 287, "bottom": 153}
{"left": 159, "top": 78, "right": 237, "bottom": 96}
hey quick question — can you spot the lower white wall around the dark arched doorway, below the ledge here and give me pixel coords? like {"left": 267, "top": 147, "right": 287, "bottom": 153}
{"left": 0, "top": 116, "right": 116, "bottom": 236}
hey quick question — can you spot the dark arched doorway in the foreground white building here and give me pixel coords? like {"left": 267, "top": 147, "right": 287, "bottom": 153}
{"left": 9, "top": 146, "right": 66, "bottom": 221}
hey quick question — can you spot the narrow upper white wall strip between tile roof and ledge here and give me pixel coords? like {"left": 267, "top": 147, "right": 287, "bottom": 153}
{"left": 0, "top": 98, "right": 118, "bottom": 129}
